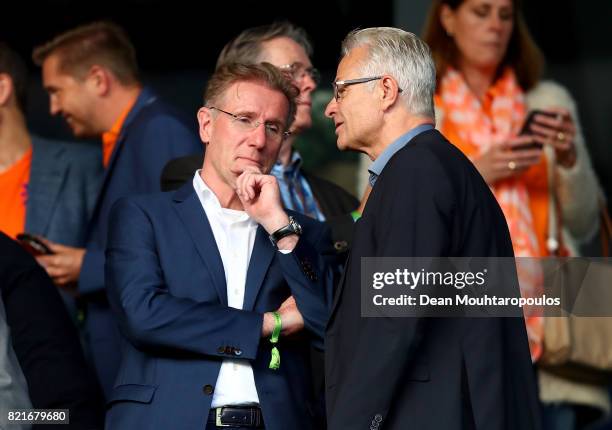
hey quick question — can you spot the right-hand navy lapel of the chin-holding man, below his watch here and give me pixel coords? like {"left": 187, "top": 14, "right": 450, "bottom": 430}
{"left": 242, "top": 226, "right": 276, "bottom": 311}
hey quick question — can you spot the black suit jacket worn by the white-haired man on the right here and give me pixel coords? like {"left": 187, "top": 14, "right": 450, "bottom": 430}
{"left": 325, "top": 130, "right": 539, "bottom": 430}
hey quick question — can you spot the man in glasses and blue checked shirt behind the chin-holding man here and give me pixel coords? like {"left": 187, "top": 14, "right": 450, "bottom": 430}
{"left": 162, "top": 22, "right": 359, "bottom": 254}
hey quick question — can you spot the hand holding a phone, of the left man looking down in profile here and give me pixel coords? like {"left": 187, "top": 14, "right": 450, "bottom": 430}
{"left": 36, "top": 238, "right": 85, "bottom": 294}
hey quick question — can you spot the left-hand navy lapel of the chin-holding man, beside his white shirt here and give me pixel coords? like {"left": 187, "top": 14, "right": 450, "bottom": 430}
{"left": 174, "top": 181, "right": 227, "bottom": 306}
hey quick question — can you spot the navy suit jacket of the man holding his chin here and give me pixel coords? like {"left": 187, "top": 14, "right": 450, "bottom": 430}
{"left": 106, "top": 183, "right": 333, "bottom": 430}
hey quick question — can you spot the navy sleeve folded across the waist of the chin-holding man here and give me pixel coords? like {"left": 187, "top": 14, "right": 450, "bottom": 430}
{"left": 106, "top": 198, "right": 263, "bottom": 359}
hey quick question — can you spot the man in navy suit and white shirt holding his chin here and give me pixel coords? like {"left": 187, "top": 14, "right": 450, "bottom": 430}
{"left": 106, "top": 63, "right": 335, "bottom": 430}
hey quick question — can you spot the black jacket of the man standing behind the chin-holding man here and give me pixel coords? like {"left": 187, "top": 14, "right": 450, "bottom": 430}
{"left": 161, "top": 153, "right": 359, "bottom": 252}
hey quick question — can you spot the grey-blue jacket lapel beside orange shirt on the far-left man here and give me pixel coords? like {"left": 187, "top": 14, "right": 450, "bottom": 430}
{"left": 25, "top": 138, "right": 68, "bottom": 236}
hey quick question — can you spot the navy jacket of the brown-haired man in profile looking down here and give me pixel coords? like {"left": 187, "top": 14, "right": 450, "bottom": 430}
{"left": 79, "top": 88, "right": 202, "bottom": 400}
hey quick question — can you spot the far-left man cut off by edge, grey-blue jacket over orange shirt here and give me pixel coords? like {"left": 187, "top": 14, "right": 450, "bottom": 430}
{"left": 0, "top": 42, "right": 103, "bottom": 330}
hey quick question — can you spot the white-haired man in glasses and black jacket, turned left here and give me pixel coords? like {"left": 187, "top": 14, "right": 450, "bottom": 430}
{"left": 325, "top": 27, "right": 539, "bottom": 430}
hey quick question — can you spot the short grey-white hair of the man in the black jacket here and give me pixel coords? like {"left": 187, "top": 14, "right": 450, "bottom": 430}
{"left": 342, "top": 27, "right": 436, "bottom": 118}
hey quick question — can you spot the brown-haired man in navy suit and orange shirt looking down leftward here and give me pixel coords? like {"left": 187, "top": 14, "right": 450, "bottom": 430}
{"left": 33, "top": 22, "right": 202, "bottom": 396}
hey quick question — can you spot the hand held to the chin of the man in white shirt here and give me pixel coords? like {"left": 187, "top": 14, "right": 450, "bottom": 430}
{"left": 236, "top": 169, "right": 289, "bottom": 234}
